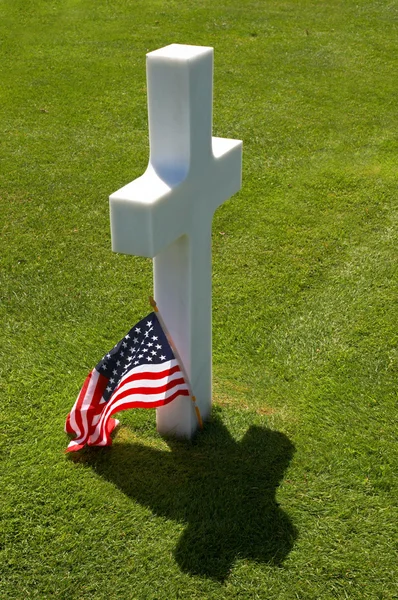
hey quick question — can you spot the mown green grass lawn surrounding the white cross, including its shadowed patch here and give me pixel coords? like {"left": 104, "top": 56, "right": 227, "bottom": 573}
{"left": 0, "top": 0, "right": 398, "bottom": 600}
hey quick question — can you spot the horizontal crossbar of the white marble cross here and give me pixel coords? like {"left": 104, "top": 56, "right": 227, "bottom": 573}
{"left": 109, "top": 138, "right": 242, "bottom": 258}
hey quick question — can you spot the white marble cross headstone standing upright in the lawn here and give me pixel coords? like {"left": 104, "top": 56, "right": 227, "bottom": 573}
{"left": 110, "top": 44, "right": 242, "bottom": 437}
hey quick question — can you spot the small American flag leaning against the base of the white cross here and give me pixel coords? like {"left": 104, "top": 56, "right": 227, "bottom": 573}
{"left": 65, "top": 312, "right": 190, "bottom": 452}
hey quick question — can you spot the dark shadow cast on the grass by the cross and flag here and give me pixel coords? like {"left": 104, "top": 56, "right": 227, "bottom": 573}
{"left": 76, "top": 416, "right": 297, "bottom": 581}
